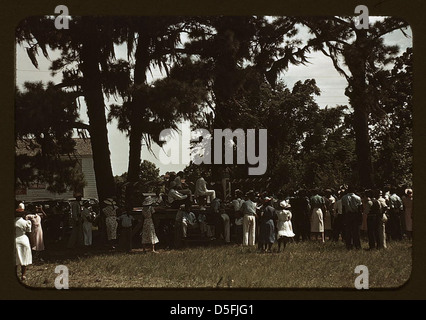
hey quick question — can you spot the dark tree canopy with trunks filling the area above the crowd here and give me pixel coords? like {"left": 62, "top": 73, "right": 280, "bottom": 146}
{"left": 16, "top": 15, "right": 413, "bottom": 200}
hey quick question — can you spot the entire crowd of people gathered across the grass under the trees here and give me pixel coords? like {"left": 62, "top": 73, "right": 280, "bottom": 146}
{"left": 15, "top": 172, "right": 413, "bottom": 279}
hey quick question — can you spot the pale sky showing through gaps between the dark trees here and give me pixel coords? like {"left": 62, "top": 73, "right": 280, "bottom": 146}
{"left": 15, "top": 18, "right": 413, "bottom": 175}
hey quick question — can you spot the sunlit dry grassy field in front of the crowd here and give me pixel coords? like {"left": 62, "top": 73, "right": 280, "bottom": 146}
{"left": 18, "top": 240, "right": 412, "bottom": 288}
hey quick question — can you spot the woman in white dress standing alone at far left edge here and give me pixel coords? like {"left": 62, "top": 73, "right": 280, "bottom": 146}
{"left": 15, "top": 203, "right": 33, "bottom": 280}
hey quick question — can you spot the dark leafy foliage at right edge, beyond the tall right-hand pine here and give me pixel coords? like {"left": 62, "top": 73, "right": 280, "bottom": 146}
{"left": 372, "top": 48, "right": 413, "bottom": 187}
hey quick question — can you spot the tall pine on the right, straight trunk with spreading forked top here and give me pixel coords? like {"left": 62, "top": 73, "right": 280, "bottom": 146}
{"left": 301, "top": 17, "right": 408, "bottom": 188}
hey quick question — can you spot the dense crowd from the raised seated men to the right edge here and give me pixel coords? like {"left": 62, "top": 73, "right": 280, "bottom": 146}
{"left": 158, "top": 172, "right": 413, "bottom": 251}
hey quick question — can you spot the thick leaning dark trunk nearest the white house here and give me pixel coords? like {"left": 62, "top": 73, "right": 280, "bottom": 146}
{"left": 80, "top": 17, "right": 115, "bottom": 201}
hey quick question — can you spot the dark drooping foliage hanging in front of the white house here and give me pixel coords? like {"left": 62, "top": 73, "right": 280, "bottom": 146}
{"left": 15, "top": 82, "right": 85, "bottom": 193}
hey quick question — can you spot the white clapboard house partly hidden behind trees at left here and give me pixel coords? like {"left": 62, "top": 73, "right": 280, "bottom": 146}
{"left": 15, "top": 138, "right": 98, "bottom": 201}
